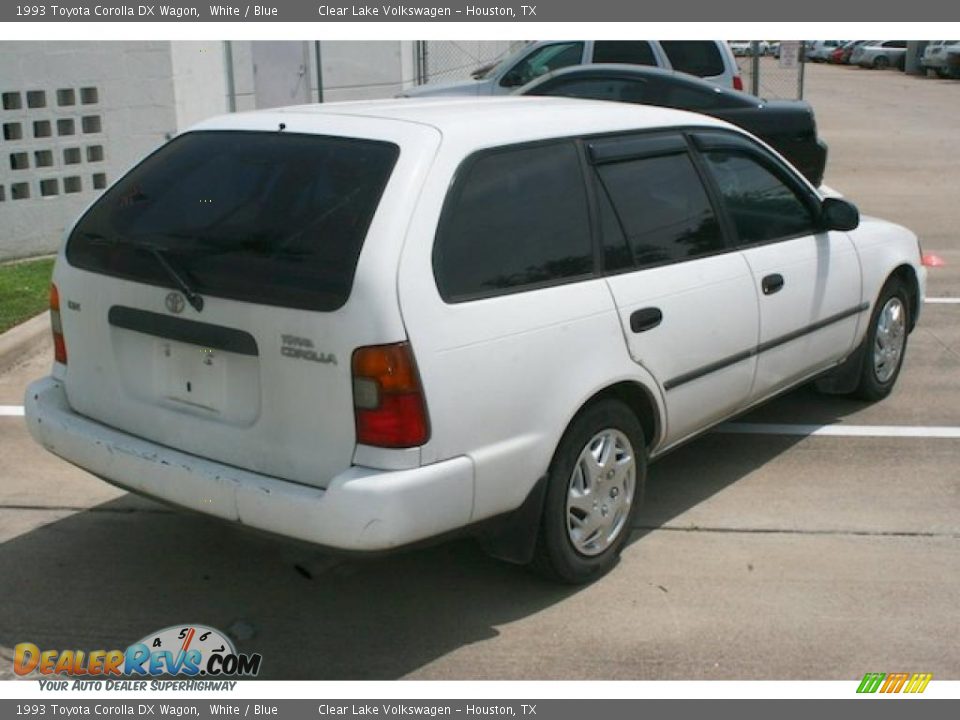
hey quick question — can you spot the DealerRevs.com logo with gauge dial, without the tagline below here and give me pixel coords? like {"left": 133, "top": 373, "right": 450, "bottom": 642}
{"left": 13, "top": 625, "right": 263, "bottom": 679}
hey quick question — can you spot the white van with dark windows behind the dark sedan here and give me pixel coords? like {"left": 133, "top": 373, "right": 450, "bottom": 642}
{"left": 402, "top": 40, "right": 743, "bottom": 97}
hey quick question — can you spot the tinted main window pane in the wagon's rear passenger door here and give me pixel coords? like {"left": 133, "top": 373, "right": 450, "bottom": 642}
{"left": 598, "top": 154, "right": 724, "bottom": 266}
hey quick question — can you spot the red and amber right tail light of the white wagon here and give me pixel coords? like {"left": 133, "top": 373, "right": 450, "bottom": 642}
{"left": 353, "top": 343, "right": 430, "bottom": 448}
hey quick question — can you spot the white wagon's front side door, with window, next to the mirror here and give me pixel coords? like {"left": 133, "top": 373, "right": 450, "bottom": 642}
{"left": 696, "top": 133, "right": 866, "bottom": 401}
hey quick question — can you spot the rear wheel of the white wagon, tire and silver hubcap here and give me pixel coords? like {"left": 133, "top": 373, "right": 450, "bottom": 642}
{"left": 531, "top": 400, "right": 647, "bottom": 584}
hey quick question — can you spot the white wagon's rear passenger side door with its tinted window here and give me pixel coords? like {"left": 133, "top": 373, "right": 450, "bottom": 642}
{"left": 589, "top": 134, "right": 759, "bottom": 445}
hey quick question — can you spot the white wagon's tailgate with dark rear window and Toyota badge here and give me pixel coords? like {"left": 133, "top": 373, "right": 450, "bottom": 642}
{"left": 56, "top": 121, "right": 437, "bottom": 486}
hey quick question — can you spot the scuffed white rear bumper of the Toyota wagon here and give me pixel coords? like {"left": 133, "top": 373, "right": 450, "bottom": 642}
{"left": 24, "top": 377, "right": 473, "bottom": 551}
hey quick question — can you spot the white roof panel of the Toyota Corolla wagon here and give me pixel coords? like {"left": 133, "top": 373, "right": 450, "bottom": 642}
{"left": 191, "top": 96, "right": 733, "bottom": 147}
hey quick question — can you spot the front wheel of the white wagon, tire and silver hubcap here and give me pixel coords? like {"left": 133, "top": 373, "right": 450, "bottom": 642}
{"left": 854, "top": 278, "right": 910, "bottom": 401}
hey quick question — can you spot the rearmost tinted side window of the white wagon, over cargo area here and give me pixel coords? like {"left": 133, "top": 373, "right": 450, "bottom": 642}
{"left": 433, "top": 143, "right": 593, "bottom": 300}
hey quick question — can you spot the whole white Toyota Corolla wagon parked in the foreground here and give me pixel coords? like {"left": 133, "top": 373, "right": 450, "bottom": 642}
{"left": 26, "top": 98, "right": 925, "bottom": 582}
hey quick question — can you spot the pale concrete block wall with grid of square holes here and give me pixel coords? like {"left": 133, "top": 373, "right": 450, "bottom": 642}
{"left": 0, "top": 41, "right": 177, "bottom": 261}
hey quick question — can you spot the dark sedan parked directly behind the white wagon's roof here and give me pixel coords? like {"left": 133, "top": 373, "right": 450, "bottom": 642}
{"left": 516, "top": 65, "right": 827, "bottom": 186}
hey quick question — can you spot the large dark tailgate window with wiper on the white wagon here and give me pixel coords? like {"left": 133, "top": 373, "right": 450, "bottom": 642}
{"left": 67, "top": 131, "right": 399, "bottom": 311}
